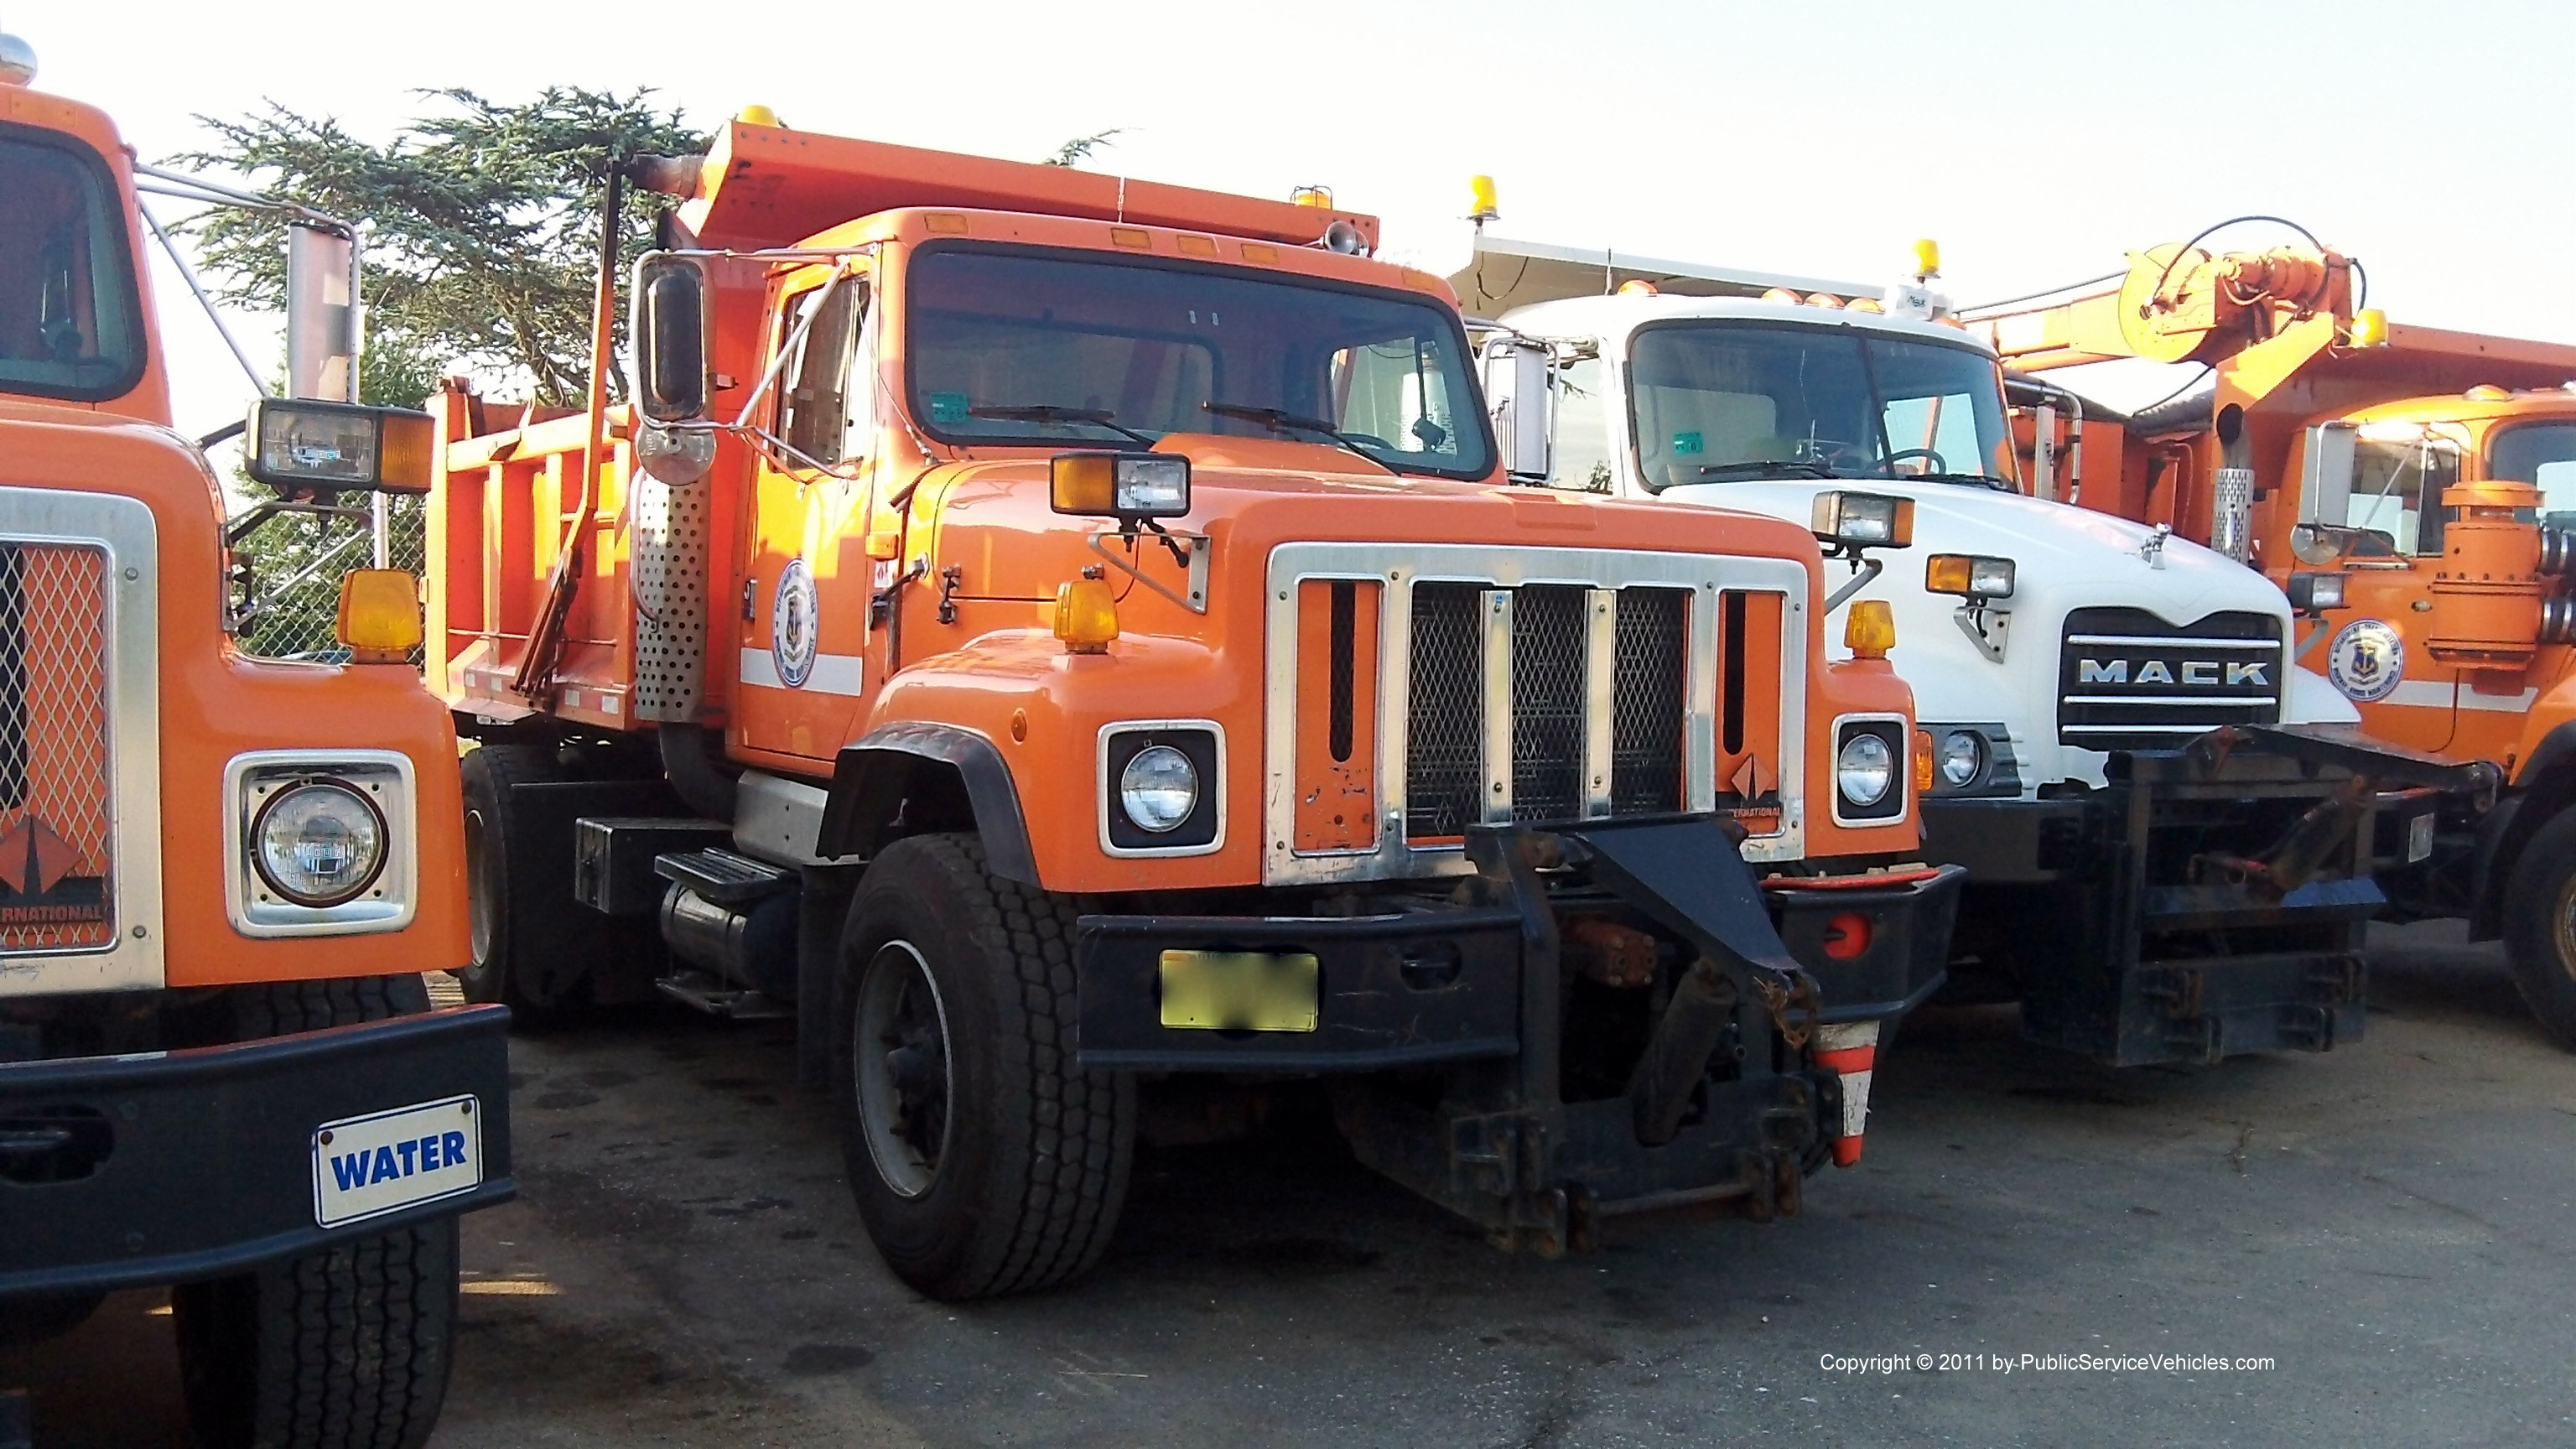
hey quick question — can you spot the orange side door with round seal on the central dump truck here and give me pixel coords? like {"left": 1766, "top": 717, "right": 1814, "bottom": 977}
{"left": 735, "top": 263, "right": 875, "bottom": 761}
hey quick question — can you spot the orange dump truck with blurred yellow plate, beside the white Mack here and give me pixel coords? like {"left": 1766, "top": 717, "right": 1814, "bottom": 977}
{"left": 428, "top": 122, "right": 1955, "bottom": 1297}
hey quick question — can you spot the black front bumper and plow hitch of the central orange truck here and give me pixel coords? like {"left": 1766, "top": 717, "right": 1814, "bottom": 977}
{"left": 1074, "top": 818, "right": 1963, "bottom": 1253}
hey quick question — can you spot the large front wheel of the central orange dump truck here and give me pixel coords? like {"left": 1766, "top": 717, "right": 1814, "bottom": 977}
{"left": 832, "top": 835, "right": 1136, "bottom": 1300}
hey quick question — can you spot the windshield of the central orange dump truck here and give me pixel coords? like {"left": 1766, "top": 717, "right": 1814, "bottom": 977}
{"left": 906, "top": 245, "right": 1494, "bottom": 477}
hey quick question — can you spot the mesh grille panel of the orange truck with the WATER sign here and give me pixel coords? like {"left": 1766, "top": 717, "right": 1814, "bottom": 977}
{"left": 0, "top": 542, "right": 116, "bottom": 954}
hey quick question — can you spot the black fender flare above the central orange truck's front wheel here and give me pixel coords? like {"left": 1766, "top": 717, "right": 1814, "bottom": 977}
{"left": 814, "top": 719, "right": 1041, "bottom": 885}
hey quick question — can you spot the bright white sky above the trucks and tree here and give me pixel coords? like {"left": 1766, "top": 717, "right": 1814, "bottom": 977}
{"left": 20, "top": 0, "right": 2576, "bottom": 430}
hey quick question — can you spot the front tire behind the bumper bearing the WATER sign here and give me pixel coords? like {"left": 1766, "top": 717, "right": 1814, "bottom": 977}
{"left": 170, "top": 977, "right": 456, "bottom": 1449}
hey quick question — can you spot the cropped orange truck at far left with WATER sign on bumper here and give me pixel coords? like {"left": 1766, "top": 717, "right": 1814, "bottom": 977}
{"left": 0, "top": 36, "right": 510, "bottom": 1449}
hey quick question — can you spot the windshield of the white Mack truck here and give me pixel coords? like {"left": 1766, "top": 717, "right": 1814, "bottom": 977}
{"left": 1628, "top": 322, "right": 2012, "bottom": 490}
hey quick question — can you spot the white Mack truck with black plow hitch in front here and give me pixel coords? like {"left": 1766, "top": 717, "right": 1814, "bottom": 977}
{"left": 1456, "top": 237, "right": 2458, "bottom": 1065}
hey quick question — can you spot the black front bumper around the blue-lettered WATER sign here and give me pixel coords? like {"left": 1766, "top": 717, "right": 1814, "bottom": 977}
{"left": 0, "top": 1005, "right": 517, "bottom": 1297}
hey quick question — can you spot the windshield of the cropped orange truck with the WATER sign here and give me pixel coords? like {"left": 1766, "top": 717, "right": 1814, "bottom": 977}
{"left": 0, "top": 127, "right": 144, "bottom": 402}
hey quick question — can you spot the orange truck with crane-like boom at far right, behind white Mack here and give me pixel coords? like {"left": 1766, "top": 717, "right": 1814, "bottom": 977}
{"left": 1989, "top": 234, "right": 2576, "bottom": 1046}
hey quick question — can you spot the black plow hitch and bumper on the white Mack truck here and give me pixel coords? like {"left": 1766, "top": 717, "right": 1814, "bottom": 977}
{"left": 1922, "top": 724, "right": 2483, "bottom": 1065}
